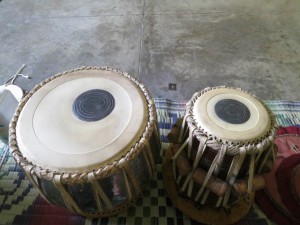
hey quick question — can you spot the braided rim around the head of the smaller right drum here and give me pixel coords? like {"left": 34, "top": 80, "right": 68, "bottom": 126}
{"left": 185, "top": 86, "right": 277, "bottom": 154}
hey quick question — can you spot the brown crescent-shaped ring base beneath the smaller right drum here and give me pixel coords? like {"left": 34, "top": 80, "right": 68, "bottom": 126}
{"left": 163, "top": 144, "right": 254, "bottom": 225}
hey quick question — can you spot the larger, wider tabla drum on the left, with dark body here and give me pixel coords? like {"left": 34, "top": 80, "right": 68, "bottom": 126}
{"left": 9, "top": 67, "right": 160, "bottom": 217}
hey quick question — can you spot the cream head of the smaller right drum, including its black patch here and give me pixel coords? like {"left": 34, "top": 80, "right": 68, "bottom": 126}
{"left": 193, "top": 87, "right": 271, "bottom": 143}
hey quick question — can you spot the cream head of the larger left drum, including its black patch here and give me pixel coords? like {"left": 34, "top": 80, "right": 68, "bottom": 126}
{"left": 16, "top": 69, "right": 148, "bottom": 172}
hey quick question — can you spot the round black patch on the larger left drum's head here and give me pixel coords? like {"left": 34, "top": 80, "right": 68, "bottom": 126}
{"left": 73, "top": 89, "right": 115, "bottom": 122}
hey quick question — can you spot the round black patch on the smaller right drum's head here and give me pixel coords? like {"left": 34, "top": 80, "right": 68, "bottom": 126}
{"left": 215, "top": 99, "right": 251, "bottom": 124}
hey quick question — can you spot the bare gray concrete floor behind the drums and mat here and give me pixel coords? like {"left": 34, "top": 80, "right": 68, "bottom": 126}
{"left": 0, "top": 0, "right": 300, "bottom": 101}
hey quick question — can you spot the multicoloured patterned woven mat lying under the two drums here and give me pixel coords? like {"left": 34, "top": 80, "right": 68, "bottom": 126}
{"left": 0, "top": 99, "right": 300, "bottom": 225}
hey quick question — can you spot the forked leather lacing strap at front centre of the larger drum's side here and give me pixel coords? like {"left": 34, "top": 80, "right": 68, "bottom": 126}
{"left": 88, "top": 172, "right": 113, "bottom": 212}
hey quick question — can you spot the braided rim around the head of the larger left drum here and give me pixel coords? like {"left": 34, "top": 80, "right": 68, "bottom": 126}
{"left": 9, "top": 66, "right": 157, "bottom": 183}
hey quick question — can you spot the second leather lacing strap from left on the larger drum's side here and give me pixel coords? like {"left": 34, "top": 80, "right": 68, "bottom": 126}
{"left": 54, "top": 175, "right": 83, "bottom": 214}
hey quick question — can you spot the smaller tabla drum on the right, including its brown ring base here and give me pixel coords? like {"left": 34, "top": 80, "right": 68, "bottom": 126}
{"left": 163, "top": 87, "right": 276, "bottom": 224}
